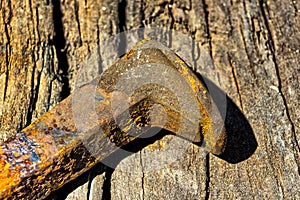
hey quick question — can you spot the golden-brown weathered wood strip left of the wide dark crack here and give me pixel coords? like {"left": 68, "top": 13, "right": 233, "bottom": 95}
{"left": 0, "top": 1, "right": 64, "bottom": 142}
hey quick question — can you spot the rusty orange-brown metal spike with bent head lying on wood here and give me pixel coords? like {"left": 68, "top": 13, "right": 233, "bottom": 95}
{"left": 0, "top": 40, "right": 226, "bottom": 199}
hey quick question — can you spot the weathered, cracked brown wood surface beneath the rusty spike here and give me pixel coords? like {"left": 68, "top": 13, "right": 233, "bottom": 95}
{"left": 0, "top": 0, "right": 300, "bottom": 199}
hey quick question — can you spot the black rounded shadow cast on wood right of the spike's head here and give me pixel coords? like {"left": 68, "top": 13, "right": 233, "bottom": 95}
{"left": 197, "top": 73, "right": 258, "bottom": 164}
